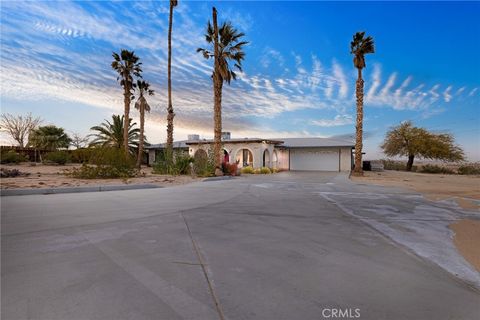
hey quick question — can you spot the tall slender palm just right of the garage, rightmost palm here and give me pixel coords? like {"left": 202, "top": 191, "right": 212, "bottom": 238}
{"left": 350, "top": 32, "right": 375, "bottom": 176}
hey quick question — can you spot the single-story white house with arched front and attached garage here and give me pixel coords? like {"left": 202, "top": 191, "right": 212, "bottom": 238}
{"left": 146, "top": 132, "right": 354, "bottom": 171}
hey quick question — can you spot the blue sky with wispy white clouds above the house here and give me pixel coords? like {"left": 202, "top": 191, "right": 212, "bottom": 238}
{"left": 0, "top": 0, "right": 480, "bottom": 161}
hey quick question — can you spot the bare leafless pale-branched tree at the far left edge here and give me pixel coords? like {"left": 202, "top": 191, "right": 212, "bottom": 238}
{"left": 0, "top": 113, "right": 42, "bottom": 147}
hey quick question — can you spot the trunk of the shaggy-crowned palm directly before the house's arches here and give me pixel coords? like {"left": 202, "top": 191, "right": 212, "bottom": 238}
{"left": 212, "top": 7, "right": 223, "bottom": 169}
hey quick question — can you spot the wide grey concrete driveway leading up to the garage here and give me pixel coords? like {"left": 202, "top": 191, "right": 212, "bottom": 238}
{"left": 1, "top": 173, "right": 480, "bottom": 320}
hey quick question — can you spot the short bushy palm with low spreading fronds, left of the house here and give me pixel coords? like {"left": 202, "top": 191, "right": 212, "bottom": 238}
{"left": 89, "top": 114, "right": 140, "bottom": 153}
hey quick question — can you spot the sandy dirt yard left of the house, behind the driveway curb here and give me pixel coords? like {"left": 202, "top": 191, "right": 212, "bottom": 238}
{"left": 0, "top": 163, "right": 199, "bottom": 189}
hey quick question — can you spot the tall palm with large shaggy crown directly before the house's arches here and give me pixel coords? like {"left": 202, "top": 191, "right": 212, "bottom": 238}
{"left": 197, "top": 7, "right": 248, "bottom": 169}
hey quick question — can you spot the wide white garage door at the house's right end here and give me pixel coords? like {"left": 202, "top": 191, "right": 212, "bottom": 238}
{"left": 290, "top": 148, "right": 339, "bottom": 171}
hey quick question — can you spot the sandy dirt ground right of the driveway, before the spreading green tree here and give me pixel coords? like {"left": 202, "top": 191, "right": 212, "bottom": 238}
{"left": 351, "top": 170, "right": 480, "bottom": 210}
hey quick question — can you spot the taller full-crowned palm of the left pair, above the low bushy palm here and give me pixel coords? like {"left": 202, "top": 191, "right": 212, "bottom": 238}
{"left": 112, "top": 49, "right": 142, "bottom": 156}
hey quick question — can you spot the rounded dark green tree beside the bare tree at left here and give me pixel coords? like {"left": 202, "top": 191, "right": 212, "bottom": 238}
{"left": 28, "top": 125, "right": 72, "bottom": 151}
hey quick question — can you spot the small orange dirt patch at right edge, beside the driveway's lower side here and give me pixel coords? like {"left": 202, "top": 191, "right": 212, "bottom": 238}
{"left": 450, "top": 219, "right": 480, "bottom": 272}
